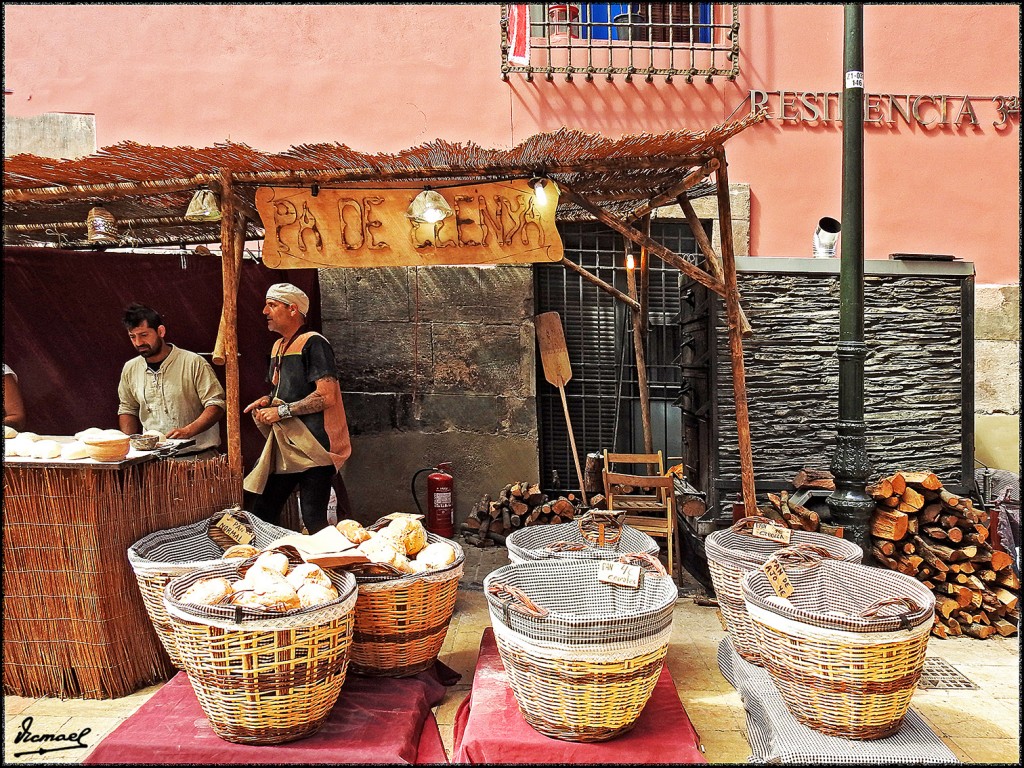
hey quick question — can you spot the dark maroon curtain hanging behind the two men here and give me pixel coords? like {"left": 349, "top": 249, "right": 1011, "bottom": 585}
{"left": 3, "top": 248, "right": 321, "bottom": 471}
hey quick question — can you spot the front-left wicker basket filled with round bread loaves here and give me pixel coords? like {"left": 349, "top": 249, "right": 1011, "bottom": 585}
{"left": 164, "top": 549, "right": 356, "bottom": 744}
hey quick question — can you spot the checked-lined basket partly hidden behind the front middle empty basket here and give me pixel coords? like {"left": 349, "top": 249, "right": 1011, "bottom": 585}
{"left": 505, "top": 510, "right": 658, "bottom": 563}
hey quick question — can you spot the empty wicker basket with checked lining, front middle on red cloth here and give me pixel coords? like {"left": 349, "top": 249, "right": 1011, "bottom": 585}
{"left": 484, "top": 554, "right": 678, "bottom": 741}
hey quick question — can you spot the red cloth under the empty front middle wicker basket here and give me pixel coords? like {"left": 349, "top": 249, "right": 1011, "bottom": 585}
{"left": 452, "top": 627, "right": 708, "bottom": 765}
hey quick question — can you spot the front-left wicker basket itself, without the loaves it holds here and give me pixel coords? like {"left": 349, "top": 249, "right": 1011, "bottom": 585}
{"left": 164, "top": 558, "right": 356, "bottom": 744}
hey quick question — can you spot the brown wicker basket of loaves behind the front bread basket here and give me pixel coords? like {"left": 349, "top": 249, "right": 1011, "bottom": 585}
{"left": 337, "top": 514, "right": 466, "bottom": 677}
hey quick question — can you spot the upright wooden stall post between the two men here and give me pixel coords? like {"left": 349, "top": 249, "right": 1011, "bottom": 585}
{"left": 220, "top": 168, "right": 245, "bottom": 501}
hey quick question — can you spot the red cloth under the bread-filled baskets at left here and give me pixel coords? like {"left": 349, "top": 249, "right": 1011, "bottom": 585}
{"left": 83, "top": 664, "right": 451, "bottom": 764}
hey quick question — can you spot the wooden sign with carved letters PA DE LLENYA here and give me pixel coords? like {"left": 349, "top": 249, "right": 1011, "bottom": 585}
{"left": 256, "top": 179, "right": 563, "bottom": 269}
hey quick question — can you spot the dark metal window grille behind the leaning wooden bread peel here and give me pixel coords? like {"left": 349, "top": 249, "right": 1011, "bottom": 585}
{"left": 535, "top": 221, "right": 702, "bottom": 494}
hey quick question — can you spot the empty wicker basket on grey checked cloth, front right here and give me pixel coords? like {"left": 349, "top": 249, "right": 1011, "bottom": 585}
{"left": 742, "top": 554, "right": 935, "bottom": 739}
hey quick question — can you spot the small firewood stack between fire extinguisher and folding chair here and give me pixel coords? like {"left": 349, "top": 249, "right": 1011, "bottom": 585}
{"left": 462, "top": 481, "right": 593, "bottom": 547}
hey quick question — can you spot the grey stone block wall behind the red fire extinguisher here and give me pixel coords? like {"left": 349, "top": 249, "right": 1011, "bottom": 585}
{"left": 319, "top": 265, "right": 539, "bottom": 525}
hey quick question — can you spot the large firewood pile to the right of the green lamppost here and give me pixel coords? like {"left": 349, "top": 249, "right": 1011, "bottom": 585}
{"left": 867, "top": 472, "right": 1020, "bottom": 638}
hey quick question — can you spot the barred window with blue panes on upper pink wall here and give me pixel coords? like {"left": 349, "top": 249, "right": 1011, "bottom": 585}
{"left": 502, "top": 3, "right": 739, "bottom": 83}
